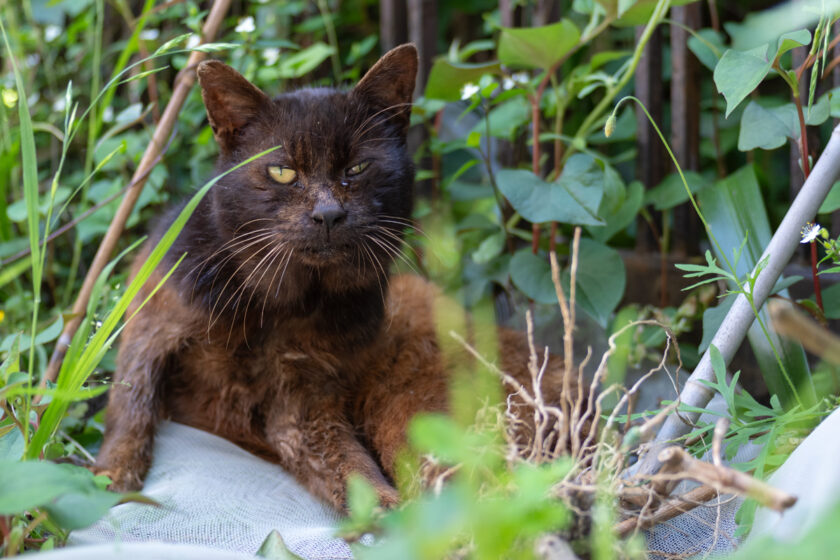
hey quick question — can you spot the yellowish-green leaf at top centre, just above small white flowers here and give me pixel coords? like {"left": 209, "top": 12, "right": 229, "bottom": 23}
{"left": 498, "top": 19, "right": 580, "bottom": 70}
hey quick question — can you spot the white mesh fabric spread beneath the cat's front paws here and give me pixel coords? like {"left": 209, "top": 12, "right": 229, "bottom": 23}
{"left": 69, "top": 422, "right": 352, "bottom": 560}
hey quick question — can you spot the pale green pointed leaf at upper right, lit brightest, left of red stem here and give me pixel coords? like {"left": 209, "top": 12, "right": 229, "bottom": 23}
{"left": 714, "top": 45, "right": 773, "bottom": 117}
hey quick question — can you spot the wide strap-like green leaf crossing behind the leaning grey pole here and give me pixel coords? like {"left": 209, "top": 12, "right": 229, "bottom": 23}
{"left": 698, "top": 165, "right": 815, "bottom": 408}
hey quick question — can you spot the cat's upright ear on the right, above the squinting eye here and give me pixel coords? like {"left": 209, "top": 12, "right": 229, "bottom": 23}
{"left": 353, "top": 43, "right": 417, "bottom": 129}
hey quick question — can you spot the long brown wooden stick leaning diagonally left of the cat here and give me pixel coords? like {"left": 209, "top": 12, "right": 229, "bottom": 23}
{"left": 41, "top": 0, "right": 231, "bottom": 387}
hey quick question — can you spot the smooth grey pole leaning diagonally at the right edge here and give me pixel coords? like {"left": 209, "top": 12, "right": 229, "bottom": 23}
{"left": 637, "top": 126, "right": 840, "bottom": 475}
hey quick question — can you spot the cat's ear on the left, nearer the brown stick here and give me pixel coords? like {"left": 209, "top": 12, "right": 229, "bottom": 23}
{"left": 196, "top": 60, "right": 271, "bottom": 151}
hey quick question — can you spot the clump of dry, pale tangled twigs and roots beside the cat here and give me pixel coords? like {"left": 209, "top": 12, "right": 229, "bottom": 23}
{"left": 456, "top": 228, "right": 796, "bottom": 559}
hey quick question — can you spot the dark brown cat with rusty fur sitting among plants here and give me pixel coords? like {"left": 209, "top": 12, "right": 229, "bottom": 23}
{"left": 97, "top": 45, "right": 572, "bottom": 509}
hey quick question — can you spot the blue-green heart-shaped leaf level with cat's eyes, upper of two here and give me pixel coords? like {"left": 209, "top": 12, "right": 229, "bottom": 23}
{"left": 496, "top": 154, "right": 604, "bottom": 225}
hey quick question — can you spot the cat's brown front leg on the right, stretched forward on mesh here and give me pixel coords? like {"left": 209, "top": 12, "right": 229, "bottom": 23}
{"left": 266, "top": 387, "right": 399, "bottom": 512}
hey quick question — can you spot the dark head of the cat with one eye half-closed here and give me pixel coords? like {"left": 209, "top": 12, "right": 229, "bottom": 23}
{"left": 197, "top": 45, "right": 417, "bottom": 288}
